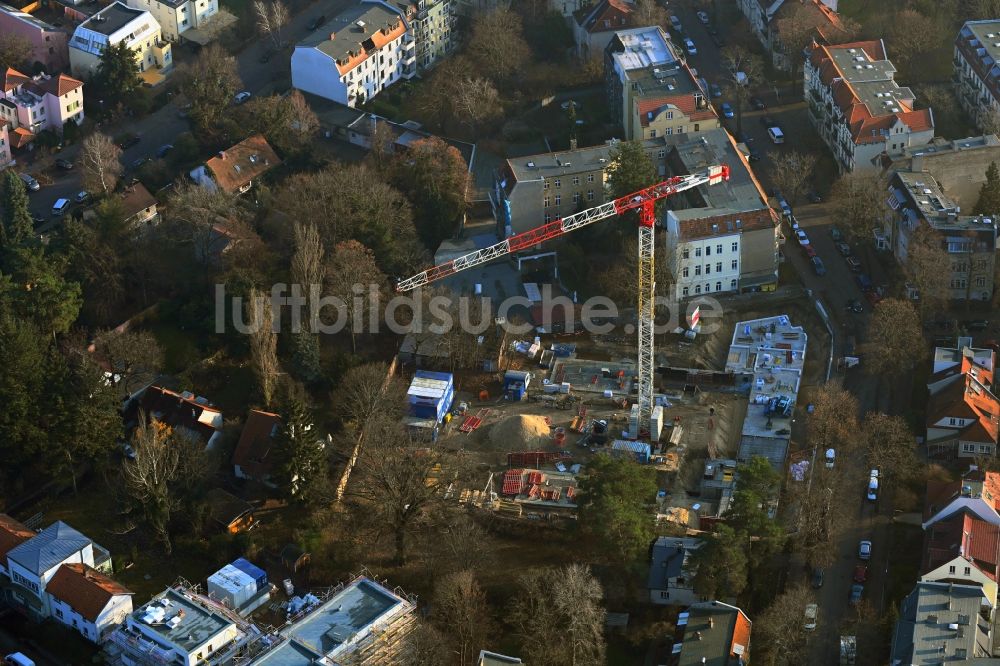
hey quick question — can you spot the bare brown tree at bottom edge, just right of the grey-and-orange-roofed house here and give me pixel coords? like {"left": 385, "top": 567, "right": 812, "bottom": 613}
{"left": 754, "top": 585, "right": 823, "bottom": 666}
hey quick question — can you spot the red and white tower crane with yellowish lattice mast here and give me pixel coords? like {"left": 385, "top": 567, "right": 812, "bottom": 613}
{"left": 396, "top": 165, "right": 729, "bottom": 434}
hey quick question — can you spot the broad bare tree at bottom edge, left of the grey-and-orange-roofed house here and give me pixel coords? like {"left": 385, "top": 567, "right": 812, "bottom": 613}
{"left": 508, "top": 564, "right": 605, "bottom": 666}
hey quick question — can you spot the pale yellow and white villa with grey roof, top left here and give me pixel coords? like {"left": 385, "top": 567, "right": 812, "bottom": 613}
{"left": 69, "top": 2, "right": 173, "bottom": 85}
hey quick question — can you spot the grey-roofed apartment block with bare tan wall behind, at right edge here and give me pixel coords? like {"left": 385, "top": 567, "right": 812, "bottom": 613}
{"left": 875, "top": 136, "right": 1000, "bottom": 301}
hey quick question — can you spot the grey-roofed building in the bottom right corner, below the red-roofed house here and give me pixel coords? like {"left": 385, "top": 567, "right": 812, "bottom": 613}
{"left": 890, "top": 582, "right": 995, "bottom": 666}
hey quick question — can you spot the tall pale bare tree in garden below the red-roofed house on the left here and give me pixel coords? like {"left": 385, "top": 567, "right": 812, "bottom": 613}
{"left": 122, "top": 414, "right": 180, "bottom": 555}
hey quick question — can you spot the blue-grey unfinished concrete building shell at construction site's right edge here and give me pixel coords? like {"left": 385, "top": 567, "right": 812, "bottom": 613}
{"left": 726, "top": 315, "right": 808, "bottom": 446}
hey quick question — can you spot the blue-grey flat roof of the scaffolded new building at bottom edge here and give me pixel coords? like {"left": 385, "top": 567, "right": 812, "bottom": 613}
{"left": 281, "top": 577, "right": 413, "bottom": 656}
